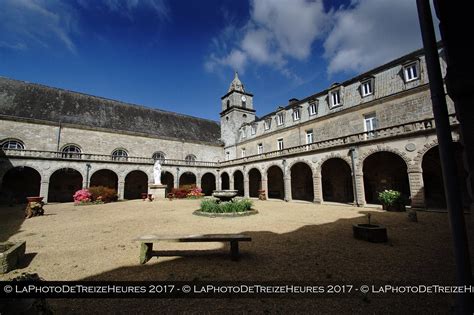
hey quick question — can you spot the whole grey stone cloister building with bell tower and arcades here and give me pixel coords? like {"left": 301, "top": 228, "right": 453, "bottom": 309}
{"left": 0, "top": 50, "right": 472, "bottom": 208}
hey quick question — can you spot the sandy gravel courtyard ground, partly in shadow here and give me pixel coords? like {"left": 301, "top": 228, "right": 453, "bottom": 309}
{"left": 0, "top": 200, "right": 474, "bottom": 314}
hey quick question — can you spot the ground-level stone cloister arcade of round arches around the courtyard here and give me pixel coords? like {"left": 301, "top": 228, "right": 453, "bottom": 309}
{"left": 0, "top": 138, "right": 472, "bottom": 208}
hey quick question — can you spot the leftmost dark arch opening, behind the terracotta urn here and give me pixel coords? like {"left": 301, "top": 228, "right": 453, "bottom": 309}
{"left": 1, "top": 165, "right": 41, "bottom": 203}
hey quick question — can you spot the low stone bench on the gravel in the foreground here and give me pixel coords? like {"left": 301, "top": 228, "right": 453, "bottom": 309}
{"left": 134, "top": 234, "right": 252, "bottom": 264}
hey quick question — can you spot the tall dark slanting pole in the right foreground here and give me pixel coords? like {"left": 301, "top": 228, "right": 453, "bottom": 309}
{"left": 416, "top": 0, "right": 472, "bottom": 314}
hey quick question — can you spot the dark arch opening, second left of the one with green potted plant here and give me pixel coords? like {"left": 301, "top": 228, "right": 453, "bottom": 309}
{"left": 290, "top": 162, "right": 314, "bottom": 201}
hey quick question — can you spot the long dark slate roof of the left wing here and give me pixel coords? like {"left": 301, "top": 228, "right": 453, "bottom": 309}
{"left": 0, "top": 77, "right": 221, "bottom": 145}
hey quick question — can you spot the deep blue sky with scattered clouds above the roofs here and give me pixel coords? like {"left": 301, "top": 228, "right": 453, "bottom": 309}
{"left": 0, "top": 0, "right": 438, "bottom": 121}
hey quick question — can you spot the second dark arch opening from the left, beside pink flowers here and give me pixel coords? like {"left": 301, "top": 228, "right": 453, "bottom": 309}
{"left": 48, "top": 167, "right": 84, "bottom": 202}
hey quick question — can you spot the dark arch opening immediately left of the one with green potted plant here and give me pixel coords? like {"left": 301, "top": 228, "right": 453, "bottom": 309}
{"left": 320, "top": 156, "right": 354, "bottom": 203}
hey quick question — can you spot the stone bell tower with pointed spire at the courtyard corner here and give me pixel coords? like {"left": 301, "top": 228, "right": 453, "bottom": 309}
{"left": 221, "top": 72, "right": 255, "bottom": 159}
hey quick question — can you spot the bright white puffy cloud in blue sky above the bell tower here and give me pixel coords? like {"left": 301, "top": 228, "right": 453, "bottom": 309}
{"left": 205, "top": 0, "right": 327, "bottom": 79}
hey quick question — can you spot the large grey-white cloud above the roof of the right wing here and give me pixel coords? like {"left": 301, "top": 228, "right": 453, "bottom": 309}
{"left": 324, "top": 0, "right": 438, "bottom": 75}
